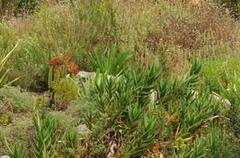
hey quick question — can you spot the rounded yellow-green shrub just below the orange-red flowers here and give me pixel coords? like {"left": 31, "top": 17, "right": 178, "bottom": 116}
{"left": 53, "top": 78, "right": 79, "bottom": 102}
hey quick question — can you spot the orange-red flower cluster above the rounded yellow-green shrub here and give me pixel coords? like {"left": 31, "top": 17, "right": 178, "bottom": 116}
{"left": 49, "top": 52, "right": 80, "bottom": 75}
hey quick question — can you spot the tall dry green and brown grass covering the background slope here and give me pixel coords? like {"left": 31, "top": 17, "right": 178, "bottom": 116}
{"left": 0, "top": 0, "right": 240, "bottom": 87}
